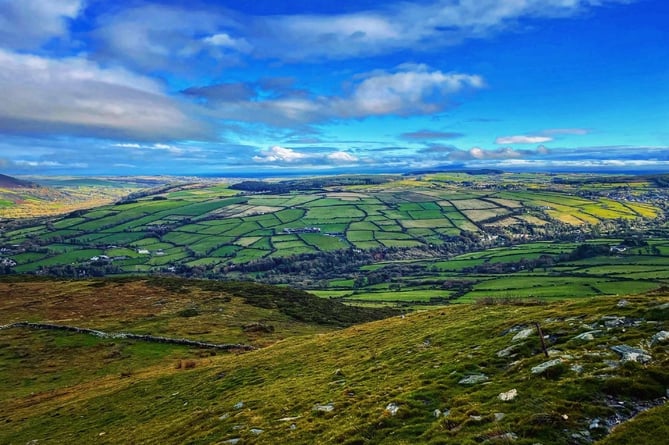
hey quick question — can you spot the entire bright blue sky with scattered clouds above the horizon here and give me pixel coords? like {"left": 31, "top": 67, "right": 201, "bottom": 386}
{"left": 0, "top": 0, "right": 669, "bottom": 176}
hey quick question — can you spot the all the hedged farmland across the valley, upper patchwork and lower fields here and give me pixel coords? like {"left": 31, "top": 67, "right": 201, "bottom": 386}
{"left": 0, "top": 173, "right": 669, "bottom": 304}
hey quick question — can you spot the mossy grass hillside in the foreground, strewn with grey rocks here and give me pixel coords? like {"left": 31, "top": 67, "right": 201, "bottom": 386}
{"left": 0, "top": 280, "right": 669, "bottom": 444}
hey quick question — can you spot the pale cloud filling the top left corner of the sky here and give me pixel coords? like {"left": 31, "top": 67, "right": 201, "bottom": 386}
{"left": 0, "top": 0, "right": 84, "bottom": 49}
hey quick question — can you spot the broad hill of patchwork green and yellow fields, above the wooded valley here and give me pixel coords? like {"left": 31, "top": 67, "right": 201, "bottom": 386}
{"left": 0, "top": 174, "right": 664, "bottom": 280}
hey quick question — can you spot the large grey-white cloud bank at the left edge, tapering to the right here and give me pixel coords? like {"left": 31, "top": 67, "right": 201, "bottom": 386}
{"left": 0, "top": 49, "right": 204, "bottom": 139}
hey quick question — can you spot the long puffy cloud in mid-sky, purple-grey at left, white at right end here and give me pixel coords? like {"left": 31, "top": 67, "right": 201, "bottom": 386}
{"left": 184, "top": 65, "right": 485, "bottom": 125}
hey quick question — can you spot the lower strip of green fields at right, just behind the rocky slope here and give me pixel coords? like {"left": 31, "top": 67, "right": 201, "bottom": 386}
{"left": 334, "top": 239, "right": 669, "bottom": 307}
